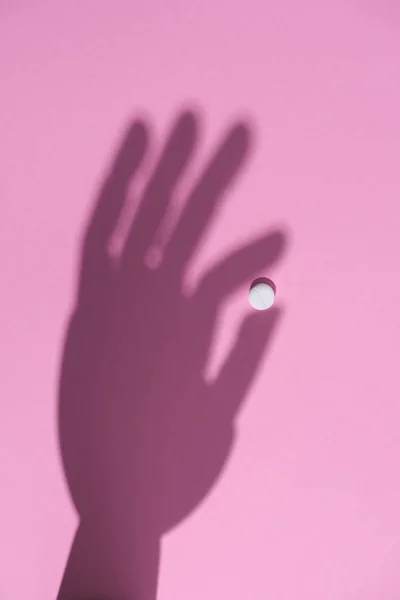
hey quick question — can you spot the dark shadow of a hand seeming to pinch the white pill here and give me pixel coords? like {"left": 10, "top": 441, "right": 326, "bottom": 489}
{"left": 59, "top": 113, "right": 284, "bottom": 600}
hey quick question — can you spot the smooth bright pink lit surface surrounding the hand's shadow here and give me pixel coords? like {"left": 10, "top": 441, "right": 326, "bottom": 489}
{"left": 0, "top": 0, "right": 400, "bottom": 600}
